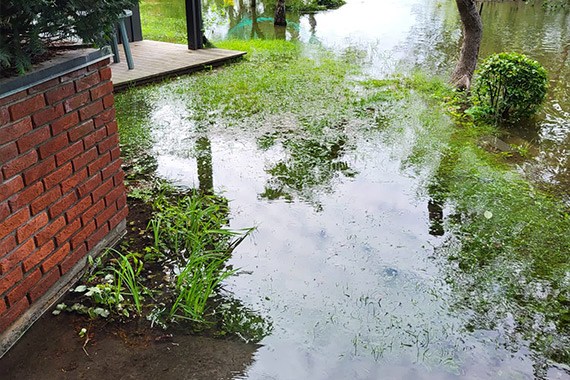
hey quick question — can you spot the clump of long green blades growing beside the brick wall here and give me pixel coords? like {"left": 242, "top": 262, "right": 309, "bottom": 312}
{"left": 149, "top": 193, "right": 252, "bottom": 322}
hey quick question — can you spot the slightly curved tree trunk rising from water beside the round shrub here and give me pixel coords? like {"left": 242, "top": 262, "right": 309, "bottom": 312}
{"left": 451, "top": 0, "right": 483, "bottom": 89}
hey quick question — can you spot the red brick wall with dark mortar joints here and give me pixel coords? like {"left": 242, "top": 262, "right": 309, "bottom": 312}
{"left": 0, "top": 59, "right": 127, "bottom": 334}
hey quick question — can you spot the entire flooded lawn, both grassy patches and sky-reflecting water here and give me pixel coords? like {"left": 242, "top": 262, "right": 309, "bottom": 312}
{"left": 0, "top": 0, "right": 570, "bottom": 380}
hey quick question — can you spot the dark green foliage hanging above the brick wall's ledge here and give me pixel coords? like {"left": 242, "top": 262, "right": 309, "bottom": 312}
{"left": 0, "top": 0, "right": 138, "bottom": 75}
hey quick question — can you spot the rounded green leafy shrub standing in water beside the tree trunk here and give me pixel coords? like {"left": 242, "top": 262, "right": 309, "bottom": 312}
{"left": 471, "top": 53, "right": 548, "bottom": 122}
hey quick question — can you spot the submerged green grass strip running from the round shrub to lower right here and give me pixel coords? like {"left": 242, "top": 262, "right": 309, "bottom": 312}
{"left": 371, "top": 75, "right": 570, "bottom": 377}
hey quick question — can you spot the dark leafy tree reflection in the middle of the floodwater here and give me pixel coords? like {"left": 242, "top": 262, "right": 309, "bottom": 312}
{"left": 260, "top": 135, "right": 355, "bottom": 208}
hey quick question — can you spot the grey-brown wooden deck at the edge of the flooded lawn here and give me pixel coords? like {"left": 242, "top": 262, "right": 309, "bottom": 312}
{"left": 111, "top": 40, "right": 245, "bottom": 91}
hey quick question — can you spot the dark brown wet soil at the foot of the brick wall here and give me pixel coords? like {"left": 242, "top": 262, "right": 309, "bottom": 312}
{"left": 0, "top": 198, "right": 259, "bottom": 379}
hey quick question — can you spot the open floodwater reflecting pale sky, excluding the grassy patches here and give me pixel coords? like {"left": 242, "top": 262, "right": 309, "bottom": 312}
{"left": 136, "top": 0, "right": 570, "bottom": 379}
